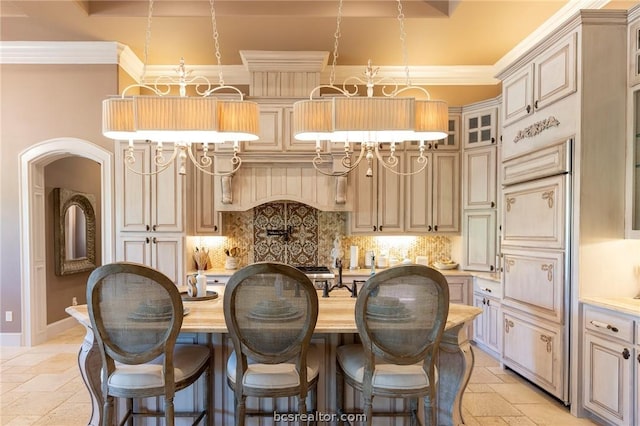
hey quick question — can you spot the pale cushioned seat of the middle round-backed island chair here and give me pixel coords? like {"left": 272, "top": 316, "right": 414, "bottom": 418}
{"left": 227, "top": 345, "right": 320, "bottom": 389}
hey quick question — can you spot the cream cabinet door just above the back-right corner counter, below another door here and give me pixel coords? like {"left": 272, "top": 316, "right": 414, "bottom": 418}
{"left": 462, "top": 210, "right": 496, "bottom": 271}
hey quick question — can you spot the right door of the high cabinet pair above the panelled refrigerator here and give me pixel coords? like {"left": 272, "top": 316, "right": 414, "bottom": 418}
{"left": 533, "top": 33, "right": 577, "bottom": 111}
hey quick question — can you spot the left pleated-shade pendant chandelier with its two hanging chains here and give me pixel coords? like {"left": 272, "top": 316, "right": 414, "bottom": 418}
{"left": 102, "top": 0, "right": 259, "bottom": 176}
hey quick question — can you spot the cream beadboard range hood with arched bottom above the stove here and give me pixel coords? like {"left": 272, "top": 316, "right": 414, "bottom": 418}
{"left": 215, "top": 154, "right": 351, "bottom": 211}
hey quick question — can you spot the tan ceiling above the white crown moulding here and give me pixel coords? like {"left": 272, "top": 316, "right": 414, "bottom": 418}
{"left": 0, "top": 0, "right": 637, "bottom": 104}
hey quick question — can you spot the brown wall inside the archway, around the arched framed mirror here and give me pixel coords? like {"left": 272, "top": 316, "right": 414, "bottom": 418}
{"left": 44, "top": 157, "right": 102, "bottom": 324}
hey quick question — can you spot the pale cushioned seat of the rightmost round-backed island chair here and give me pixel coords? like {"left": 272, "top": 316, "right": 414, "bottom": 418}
{"left": 337, "top": 344, "right": 438, "bottom": 391}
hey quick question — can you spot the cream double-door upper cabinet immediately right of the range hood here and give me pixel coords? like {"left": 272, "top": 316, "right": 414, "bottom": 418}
{"left": 349, "top": 152, "right": 404, "bottom": 234}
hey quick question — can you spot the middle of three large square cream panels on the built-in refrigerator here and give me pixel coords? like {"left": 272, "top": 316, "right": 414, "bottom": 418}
{"left": 503, "top": 250, "right": 565, "bottom": 323}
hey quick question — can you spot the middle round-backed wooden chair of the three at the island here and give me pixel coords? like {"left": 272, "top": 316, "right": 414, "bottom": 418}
{"left": 224, "top": 262, "right": 319, "bottom": 425}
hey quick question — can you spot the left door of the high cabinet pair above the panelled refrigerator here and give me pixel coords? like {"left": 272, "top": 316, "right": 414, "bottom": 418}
{"left": 502, "top": 64, "right": 534, "bottom": 126}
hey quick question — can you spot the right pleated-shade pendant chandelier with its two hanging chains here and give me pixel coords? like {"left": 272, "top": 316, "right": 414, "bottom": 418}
{"left": 293, "top": 0, "right": 449, "bottom": 177}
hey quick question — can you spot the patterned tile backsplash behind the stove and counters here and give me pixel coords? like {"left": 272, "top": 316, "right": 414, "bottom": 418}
{"left": 187, "top": 202, "right": 455, "bottom": 269}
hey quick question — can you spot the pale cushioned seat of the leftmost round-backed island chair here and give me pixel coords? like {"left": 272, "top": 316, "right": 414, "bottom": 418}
{"left": 109, "top": 345, "right": 209, "bottom": 392}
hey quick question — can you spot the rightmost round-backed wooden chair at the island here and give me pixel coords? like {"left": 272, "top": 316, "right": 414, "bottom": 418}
{"left": 336, "top": 265, "right": 449, "bottom": 425}
